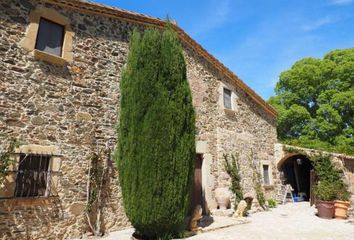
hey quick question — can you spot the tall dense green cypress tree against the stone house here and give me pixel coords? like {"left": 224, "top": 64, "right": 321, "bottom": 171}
{"left": 116, "top": 26, "right": 195, "bottom": 238}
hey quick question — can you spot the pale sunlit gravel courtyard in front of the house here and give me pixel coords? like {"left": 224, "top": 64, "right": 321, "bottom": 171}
{"left": 188, "top": 202, "right": 354, "bottom": 240}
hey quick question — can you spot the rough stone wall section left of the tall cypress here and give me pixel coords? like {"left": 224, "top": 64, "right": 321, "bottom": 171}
{"left": 0, "top": 0, "right": 132, "bottom": 239}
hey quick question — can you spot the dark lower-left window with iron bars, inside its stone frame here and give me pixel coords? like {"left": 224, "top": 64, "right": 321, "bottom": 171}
{"left": 14, "top": 154, "right": 51, "bottom": 197}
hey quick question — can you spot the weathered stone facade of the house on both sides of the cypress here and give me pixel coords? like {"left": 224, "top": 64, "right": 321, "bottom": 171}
{"left": 0, "top": 0, "right": 277, "bottom": 239}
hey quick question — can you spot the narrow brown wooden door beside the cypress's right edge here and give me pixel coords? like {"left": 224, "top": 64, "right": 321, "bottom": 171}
{"left": 191, "top": 154, "right": 204, "bottom": 212}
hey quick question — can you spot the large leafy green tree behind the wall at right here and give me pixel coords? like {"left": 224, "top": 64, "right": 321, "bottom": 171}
{"left": 269, "top": 48, "right": 354, "bottom": 155}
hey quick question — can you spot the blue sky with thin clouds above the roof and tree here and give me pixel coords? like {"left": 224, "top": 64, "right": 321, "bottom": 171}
{"left": 94, "top": 0, "right": 354, "bottom": 99}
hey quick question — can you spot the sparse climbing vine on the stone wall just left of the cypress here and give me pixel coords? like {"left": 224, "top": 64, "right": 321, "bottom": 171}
{"left": 85, "top": 148, "right": 110, "bottom": 236}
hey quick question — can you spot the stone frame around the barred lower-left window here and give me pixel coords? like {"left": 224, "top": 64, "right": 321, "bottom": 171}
{"left": 0, "top": 144, "right": 62, "bottom": 200}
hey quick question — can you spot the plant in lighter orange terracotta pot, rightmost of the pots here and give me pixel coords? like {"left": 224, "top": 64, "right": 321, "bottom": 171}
{"left": 334, "top": 183, "right": 350, "bottom": 219}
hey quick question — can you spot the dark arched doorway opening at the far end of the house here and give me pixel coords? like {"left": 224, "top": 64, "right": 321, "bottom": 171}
{"left": 278, "top": 154, "right": 313, "bottom": 201}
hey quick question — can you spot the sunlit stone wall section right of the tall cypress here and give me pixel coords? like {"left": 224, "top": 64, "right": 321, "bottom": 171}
{"left": 186, "top": 46, "right": 278, "bottom": 208}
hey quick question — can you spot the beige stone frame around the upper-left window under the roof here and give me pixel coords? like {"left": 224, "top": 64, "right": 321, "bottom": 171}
{"left": 20, "top": 6, "right": 74, "bottom": 65}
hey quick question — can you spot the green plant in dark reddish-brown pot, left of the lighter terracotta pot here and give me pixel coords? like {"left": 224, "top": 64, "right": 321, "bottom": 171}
{"left": 315, "top": 180, "right": 337, "bottom": 219}
